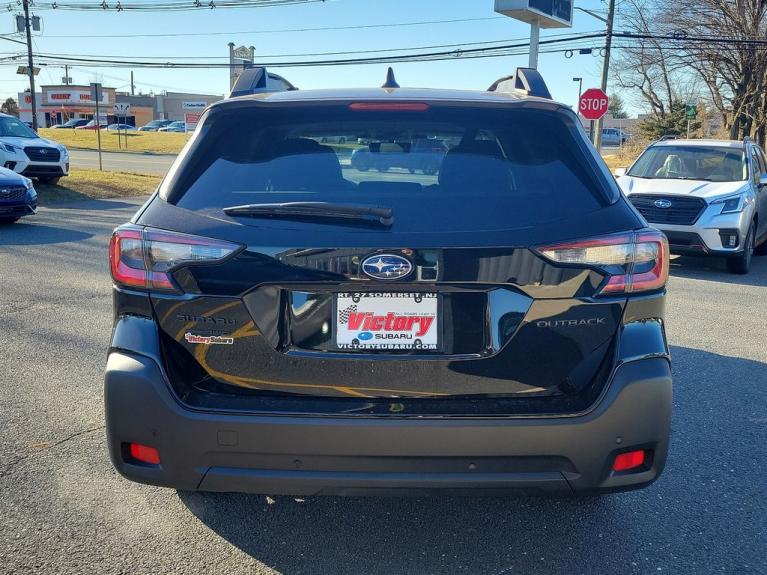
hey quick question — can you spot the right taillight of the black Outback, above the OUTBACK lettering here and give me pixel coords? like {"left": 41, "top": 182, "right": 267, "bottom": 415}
{"left": 535, "top": 229, "right": 669, "bottom": 295}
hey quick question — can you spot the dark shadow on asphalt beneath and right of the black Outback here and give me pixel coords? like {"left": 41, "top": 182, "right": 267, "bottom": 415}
{"left": 178, "top": 347, "right": 767, "bottom": 575}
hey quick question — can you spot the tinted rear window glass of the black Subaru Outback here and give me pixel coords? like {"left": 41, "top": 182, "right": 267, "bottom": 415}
{"left": 168, "top": 106, "right": 615, "bottom": 231}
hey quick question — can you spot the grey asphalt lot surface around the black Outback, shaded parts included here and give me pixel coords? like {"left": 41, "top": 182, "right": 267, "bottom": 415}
{"left": 0, "top": 199, "right": 767, "bottom": 575}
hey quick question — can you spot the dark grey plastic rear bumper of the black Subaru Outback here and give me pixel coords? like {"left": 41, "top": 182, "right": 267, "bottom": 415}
{"left": 105, "top": 352, "right": 671, "bottom": 495}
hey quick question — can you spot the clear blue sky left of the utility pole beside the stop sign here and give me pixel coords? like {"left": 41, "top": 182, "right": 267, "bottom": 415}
{"left": 0, "top": 0, "right": 604, "bottom": 112}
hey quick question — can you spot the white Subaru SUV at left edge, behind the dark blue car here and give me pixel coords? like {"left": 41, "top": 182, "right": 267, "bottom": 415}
{"left": 0, "top": 114, "right": 69, "bottom": 184}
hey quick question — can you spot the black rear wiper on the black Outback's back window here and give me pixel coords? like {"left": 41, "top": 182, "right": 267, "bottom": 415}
{"left": 224, "top": 202, "right": 394, "bottom": 227}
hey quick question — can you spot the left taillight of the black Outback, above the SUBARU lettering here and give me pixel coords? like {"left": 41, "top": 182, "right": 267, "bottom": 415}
{"left": 109, "top": 224, "right": 240, "bottom": 291}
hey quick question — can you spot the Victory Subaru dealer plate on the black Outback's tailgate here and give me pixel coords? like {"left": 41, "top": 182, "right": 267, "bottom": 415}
{"left": 335, "top": 292, "right": 440, "bottom": 350}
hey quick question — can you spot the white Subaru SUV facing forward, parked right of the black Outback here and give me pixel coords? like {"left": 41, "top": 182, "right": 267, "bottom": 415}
{"left": 615, "top": 138, "right": 767, "bottom": 274}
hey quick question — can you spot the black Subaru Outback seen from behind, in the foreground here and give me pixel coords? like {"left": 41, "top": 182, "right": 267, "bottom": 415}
{"left": 105, "top": 67, "right": 671, "bottom": 495}
